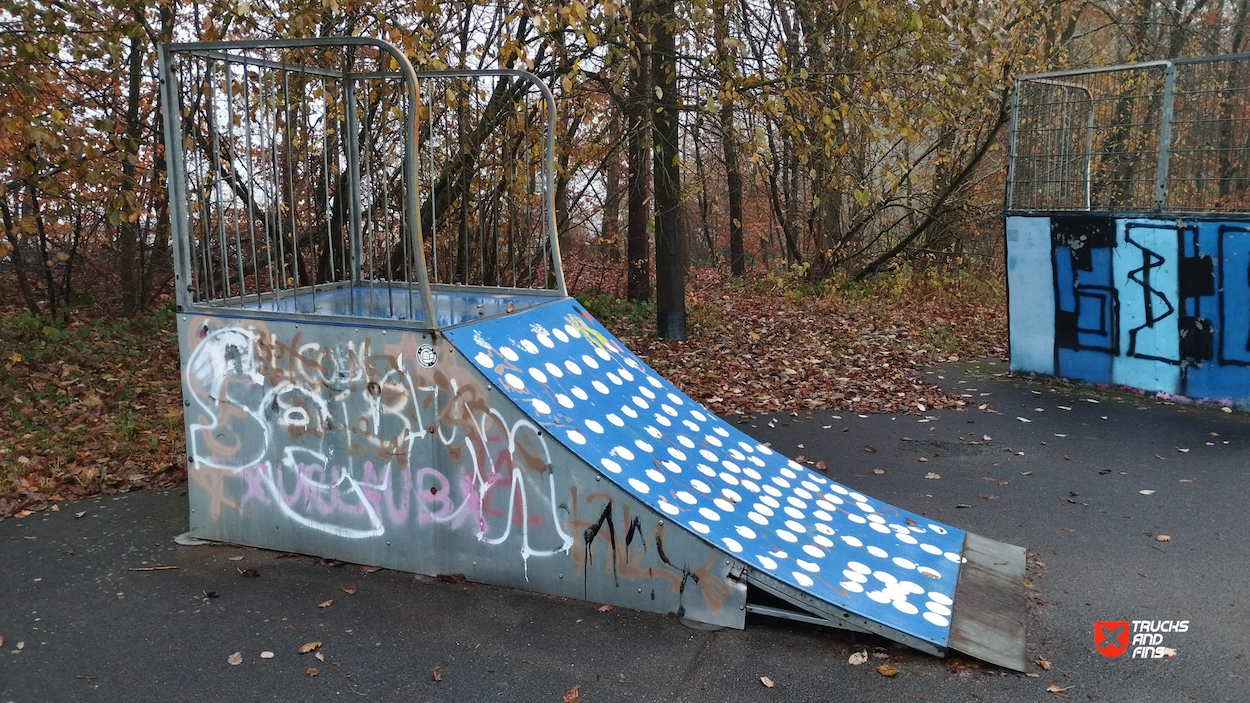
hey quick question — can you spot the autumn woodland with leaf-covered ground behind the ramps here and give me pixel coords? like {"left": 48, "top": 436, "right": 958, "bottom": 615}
{"left": 0, "top": 0, "right": 1250, "bottom": 519}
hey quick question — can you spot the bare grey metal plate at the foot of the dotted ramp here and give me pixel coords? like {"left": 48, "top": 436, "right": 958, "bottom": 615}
{"left": 950, "top": 533, "right": 1025, "bottom": 672}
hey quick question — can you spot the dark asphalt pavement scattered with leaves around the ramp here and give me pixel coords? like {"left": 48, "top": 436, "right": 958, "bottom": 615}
{"left": 0, "top": 362, "right": 1250, "bottom": 703}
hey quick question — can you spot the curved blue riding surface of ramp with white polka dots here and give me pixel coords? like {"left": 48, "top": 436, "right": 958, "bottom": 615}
{"left": 446, "top": 299, "right": 964, "bottom": 647}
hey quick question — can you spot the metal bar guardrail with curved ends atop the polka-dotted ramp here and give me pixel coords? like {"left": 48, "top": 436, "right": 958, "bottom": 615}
{"left": 160, "top": 38, "right": 565, "bottom": 328}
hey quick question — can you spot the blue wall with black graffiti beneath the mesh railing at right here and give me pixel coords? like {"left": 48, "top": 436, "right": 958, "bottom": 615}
{"left": 1006, "top": 213, "right": 1250, "bottom": 409}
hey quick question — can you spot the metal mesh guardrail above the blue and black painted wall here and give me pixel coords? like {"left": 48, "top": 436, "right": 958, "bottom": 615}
{"left": 1006, "top": 54, "right": 1250, "bottom": 215}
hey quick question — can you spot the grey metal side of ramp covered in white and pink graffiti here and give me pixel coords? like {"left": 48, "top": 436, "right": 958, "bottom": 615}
{"left": 179, "top": 313, "right": 746, "bottom": 628}
